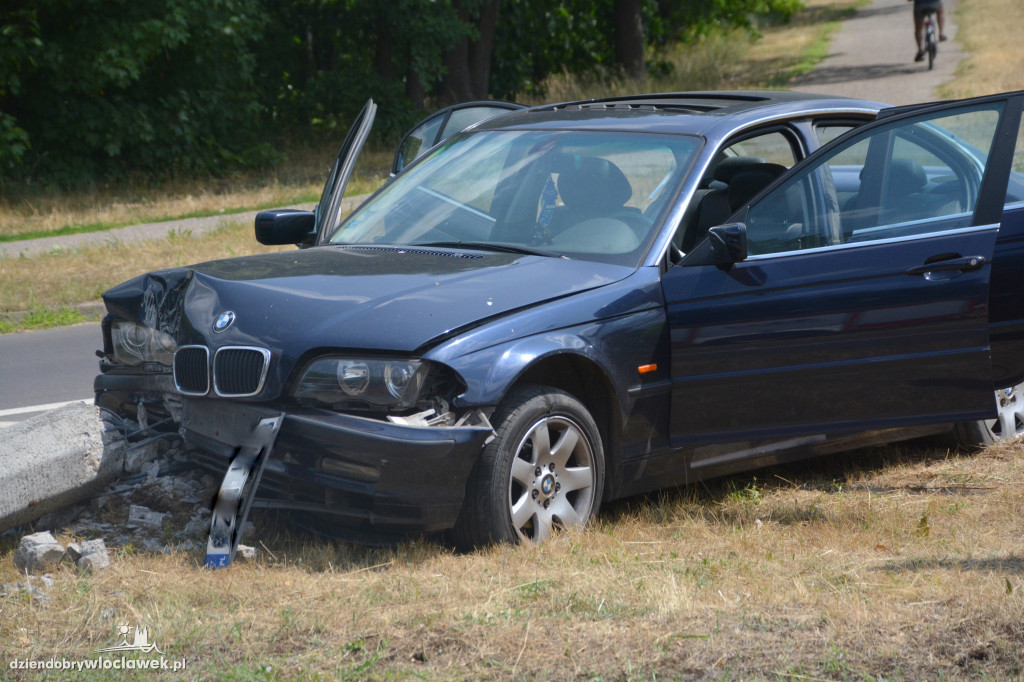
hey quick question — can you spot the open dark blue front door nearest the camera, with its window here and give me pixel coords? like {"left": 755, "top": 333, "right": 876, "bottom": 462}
{"left": 664, "top": 93, "right": 1022, "bottom": 446}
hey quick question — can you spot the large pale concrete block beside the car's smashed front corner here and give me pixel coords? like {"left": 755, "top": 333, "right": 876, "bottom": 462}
{"left": 0, "top": 402, "right": 124, "bottom": 532}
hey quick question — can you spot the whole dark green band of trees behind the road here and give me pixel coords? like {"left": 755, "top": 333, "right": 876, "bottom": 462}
{"left": 0, "top": 0, "right": 801, "bottom": 183}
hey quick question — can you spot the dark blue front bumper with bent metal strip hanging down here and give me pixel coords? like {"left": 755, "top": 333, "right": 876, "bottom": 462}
{"left": 181, "top": 398, "right": 493, "bottom": 548}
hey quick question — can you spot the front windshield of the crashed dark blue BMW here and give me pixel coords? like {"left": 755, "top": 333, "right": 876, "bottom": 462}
{"left": 330, "top": 130, "right": 700, "bottom": 266}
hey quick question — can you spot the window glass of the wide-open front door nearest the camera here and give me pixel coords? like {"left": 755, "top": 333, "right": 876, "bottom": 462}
{"left": 746, "top": 102, "right": 1002, "bottom": 254}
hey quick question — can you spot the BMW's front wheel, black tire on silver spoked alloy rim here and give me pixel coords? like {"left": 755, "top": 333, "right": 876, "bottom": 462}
{"left": 449, "top": 386, "right": 604, "bottom": 551}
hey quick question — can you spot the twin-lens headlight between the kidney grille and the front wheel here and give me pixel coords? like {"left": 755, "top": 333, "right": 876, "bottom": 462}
{"left": 294, "top": 357, "right": 428, "bottom": 408}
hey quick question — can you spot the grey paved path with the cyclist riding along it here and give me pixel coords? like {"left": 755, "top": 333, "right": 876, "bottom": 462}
{"left": 791, "top": 0, "right": 964, "bottom": 104}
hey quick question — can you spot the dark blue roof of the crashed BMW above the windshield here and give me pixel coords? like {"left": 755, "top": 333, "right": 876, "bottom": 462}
{"left": 475, "top": 90, "right": 886, "bottom": 137}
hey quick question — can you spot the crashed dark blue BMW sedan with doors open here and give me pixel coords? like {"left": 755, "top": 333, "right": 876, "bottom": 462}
{"left": 95, "top": 87, "right": 1024, "bottom": 565}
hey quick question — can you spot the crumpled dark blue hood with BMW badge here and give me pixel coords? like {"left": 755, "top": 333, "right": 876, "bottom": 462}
{"left": 103, "top": 246, "right": 633, "bottom": 350}
